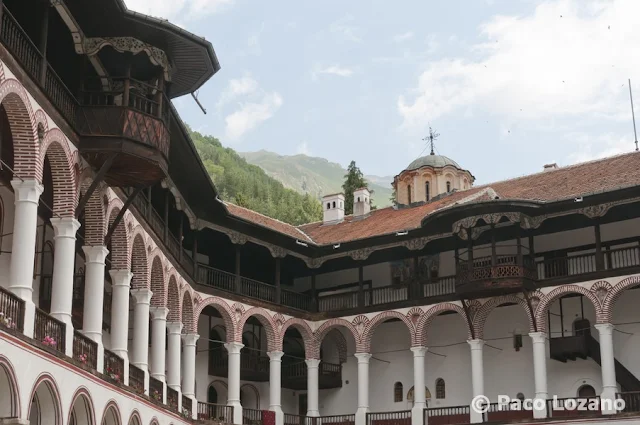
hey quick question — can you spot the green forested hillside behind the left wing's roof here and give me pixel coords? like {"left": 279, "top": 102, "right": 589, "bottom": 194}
{"left": 189, "top": 129, "right": 322, "bottom": 225}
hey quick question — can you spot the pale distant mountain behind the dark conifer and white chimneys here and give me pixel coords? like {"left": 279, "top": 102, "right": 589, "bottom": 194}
{"left": 239, "top": 150, "right": 393, "bottom": 208}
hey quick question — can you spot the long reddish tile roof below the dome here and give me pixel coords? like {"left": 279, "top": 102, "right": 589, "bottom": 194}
{"left": 227, "top": 152, "right": 640, "bottom": 245}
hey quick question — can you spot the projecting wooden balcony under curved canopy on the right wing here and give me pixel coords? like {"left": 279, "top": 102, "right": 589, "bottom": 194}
{"left": 456, "top": 254, "right": 537, "bottom": 298}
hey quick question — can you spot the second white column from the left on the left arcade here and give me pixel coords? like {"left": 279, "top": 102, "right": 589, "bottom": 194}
{"left": 51, "top": 217, "right": 80, "bottom": 357}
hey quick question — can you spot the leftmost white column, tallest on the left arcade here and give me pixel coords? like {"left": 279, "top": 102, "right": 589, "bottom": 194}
{"left": 9, "top": 180, "right": 44, "bottom": 337}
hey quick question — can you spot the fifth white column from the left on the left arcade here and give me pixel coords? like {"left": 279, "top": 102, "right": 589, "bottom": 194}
{"left": 131, "top": 289, "right": 153, "bottom": 394}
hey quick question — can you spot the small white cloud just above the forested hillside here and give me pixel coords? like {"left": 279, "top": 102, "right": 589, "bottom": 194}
{"left": 224, "top": 92, "right": 283, "bottom": 141}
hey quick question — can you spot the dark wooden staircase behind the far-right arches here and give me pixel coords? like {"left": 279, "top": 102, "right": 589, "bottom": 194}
{"left": 549, "top": 333, "right": 640, "bottom": 392}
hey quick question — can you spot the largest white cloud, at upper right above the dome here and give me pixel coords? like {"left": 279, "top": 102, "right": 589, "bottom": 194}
{"left": 397, "top": 0, "right": 640, "bottom": 129}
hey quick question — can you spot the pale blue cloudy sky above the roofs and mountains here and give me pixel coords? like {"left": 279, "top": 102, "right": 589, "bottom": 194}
{"left": 126, "top": 0, "right": 640, "bottom": 184}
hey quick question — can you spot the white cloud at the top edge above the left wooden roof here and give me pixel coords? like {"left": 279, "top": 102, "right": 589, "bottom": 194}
{"left": 125, "top": 0, "right": 235, "bottom": 20}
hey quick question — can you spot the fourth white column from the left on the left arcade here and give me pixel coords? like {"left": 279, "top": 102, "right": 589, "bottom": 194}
{"left": 109, "top": 270, "right": 133, "bottom": 385}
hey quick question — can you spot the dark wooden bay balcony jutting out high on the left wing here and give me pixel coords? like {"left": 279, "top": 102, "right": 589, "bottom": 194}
{"left": 75, "top": 78, "right": 170, "bottom": 187}
